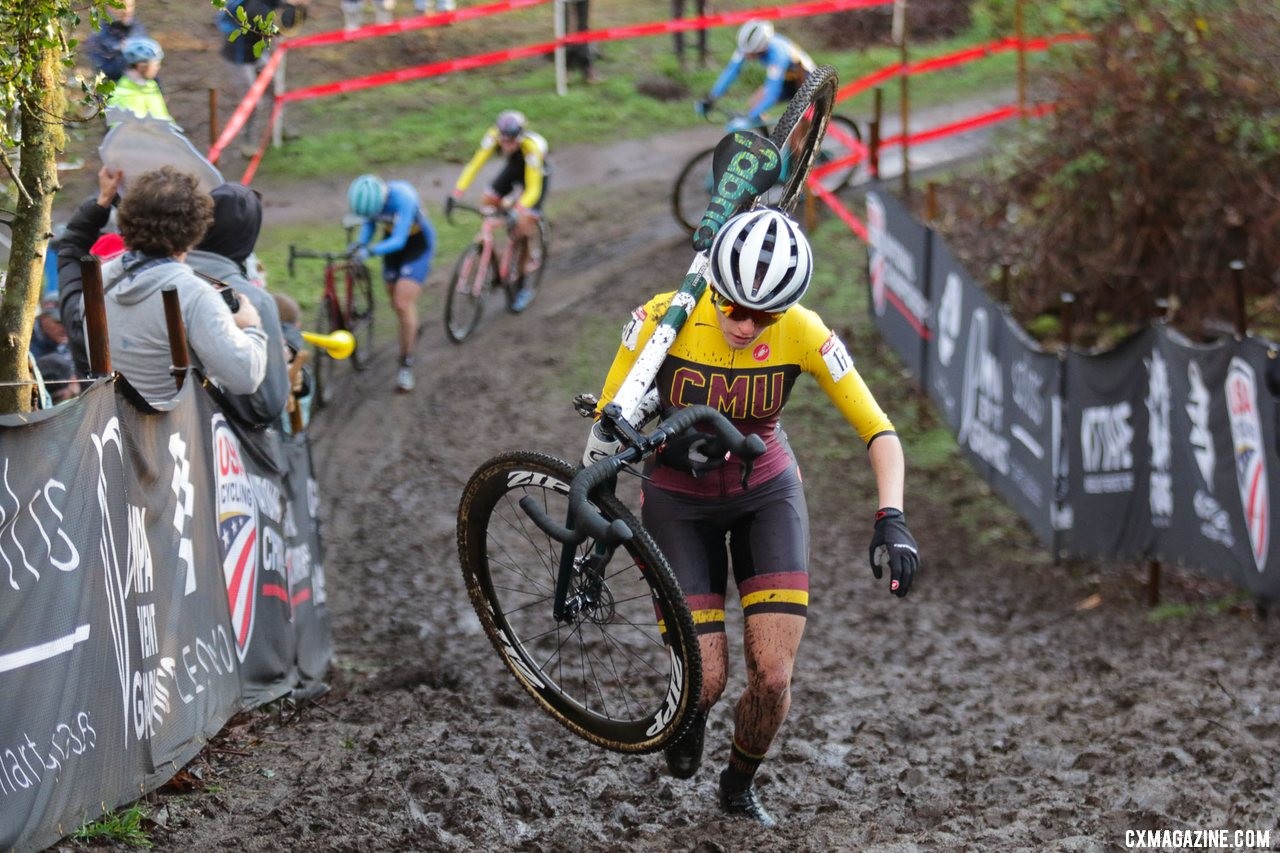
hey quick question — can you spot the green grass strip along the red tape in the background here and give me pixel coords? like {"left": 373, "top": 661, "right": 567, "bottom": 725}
{"left": 261, "top": 6, "right": 1042, "bottom": 182}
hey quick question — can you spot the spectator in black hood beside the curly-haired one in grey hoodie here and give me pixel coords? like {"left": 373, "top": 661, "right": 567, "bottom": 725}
{"left": 187, "top": 183, "right": 289, "bottom": 427}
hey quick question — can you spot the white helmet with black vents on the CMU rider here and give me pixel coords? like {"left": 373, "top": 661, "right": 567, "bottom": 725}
{"left": 710, "top": 207, "right": 813, "bottom": 314}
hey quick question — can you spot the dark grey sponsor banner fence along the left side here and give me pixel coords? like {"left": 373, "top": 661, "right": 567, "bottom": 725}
{"left": 0, "top": 382, "right": 332, "bottom": 850}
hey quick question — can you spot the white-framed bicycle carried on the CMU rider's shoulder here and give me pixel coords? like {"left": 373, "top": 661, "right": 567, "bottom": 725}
{"left": 457, "top": 67, "right": 836, "bottom": 753}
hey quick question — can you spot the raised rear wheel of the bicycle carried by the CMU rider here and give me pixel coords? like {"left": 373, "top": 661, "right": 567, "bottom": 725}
{"left": 755, "top": 65, "right": 840, "bottom": 213}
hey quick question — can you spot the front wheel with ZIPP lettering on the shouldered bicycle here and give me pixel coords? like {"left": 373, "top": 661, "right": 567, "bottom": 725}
{"left": 458, "top": 451, "right": 701, "bottom": 753}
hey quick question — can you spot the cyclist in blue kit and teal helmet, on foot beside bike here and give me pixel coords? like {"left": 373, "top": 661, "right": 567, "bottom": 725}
{"left": 347, "top": 174, "right": 435, "bottom": 392}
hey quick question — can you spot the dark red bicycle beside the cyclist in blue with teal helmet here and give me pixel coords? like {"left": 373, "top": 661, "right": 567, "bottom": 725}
{"left": 288, "top": 245, "right": 374, "bottom": 409}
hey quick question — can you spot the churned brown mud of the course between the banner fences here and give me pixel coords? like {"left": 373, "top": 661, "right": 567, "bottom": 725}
{"left": 49, "top": 4, "right": 1280, "bottom": 852}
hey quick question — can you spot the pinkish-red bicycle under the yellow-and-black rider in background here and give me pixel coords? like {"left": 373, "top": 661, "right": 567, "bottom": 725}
{"left": 444, "top": 199, "right": 550, "bottom": 343}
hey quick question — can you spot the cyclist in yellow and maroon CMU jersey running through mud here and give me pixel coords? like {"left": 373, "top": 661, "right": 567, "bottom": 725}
{"left": 584, "top": 209, "right": 918, "bottom": 826}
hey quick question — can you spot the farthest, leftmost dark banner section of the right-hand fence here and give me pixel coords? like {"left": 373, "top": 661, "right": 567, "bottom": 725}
{"left": 867, "top": 191, "right": 931, "bottom": 380}
